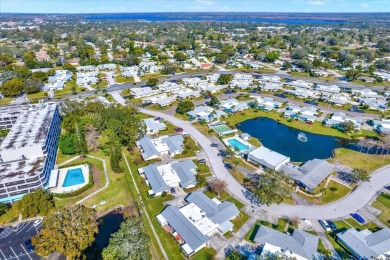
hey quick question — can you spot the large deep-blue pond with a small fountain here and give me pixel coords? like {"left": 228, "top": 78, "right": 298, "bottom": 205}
{"left": 236, "top": 117, "right": 373, "bottom": 162}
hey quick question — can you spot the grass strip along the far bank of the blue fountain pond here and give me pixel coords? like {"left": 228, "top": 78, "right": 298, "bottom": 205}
{"left": 225, "top": 109, "right": 350, "bottom": 138}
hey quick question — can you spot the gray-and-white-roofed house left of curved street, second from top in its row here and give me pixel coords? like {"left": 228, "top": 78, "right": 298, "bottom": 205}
{"left": 136, "top": 135, "right": 184, "bottom": 161}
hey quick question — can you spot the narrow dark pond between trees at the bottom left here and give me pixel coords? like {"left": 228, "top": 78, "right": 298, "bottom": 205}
{"left": 85, "top": 212, "right": 123, "bottom": 259}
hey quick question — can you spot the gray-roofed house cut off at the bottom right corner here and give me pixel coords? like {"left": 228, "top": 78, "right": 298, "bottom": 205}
{"left": 337, "top": 228, "right": 390, "bottom": 259}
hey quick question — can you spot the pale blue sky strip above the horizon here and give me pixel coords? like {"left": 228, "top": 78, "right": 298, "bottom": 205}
{"left": 0, "top": 0, "right": 390, "bottom": 13}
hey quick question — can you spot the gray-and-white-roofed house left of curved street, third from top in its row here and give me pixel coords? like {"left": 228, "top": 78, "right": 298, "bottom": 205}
{"left": 138, "top": 160, "right": 197, "bottom": 196}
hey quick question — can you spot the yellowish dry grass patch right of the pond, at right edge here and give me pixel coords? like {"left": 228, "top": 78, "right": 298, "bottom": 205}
{"left": 331, "top": 148, "right": 390, "bottom": 173}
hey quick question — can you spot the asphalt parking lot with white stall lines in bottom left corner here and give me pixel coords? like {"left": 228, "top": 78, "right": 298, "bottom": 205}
{"left": 0, "top": 221, "right": 41, "bottom": 260}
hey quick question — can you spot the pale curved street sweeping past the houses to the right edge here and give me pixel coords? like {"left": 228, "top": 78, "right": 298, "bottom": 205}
{"left": 139, "top": 108, "right": 390, "bottom": 219}
